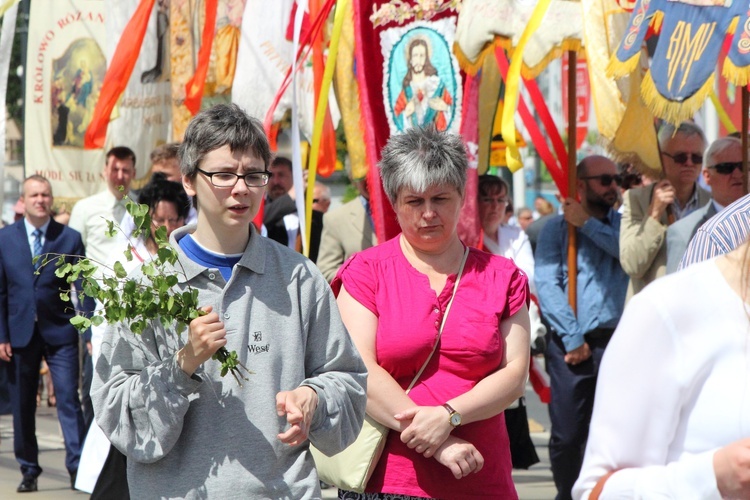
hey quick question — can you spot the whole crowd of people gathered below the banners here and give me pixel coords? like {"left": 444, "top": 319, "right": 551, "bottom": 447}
{"left": 0, "top": 105, "right": 750, "bottom": 500}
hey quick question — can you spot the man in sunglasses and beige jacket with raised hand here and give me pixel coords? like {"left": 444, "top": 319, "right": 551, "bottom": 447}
{"left": 620, "top": 122, "right": 711, "bottom": 299}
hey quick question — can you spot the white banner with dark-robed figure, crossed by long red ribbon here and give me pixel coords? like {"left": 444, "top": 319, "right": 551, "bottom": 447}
{"left": 104, "top": 0, "right": 171, "bottom": 185}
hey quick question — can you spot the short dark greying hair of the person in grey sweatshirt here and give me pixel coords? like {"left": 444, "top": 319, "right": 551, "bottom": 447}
{"left": 179, "top": 104, "right": 271, "bottom": 179}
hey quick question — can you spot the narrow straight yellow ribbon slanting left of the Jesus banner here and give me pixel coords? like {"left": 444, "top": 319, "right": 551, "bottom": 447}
{"left": 303, "top": 0, "right": 349, "bottom": 257}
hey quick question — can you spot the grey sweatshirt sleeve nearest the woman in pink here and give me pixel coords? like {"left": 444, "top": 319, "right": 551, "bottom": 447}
{"left": 302, "top": 282, "right": 367, "bottom": 455}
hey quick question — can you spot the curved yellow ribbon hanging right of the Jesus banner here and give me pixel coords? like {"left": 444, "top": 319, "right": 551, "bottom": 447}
{"left": 502, "top": 0, "right": 556, "bottom": 172}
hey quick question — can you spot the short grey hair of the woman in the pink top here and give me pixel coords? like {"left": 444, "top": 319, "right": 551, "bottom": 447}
{"left": 378, "top": 127, "right": 469, "bottom": 205}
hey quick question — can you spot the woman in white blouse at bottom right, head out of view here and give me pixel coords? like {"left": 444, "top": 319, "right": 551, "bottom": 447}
{"left": 573, "top": 236, "right": 750, "bottom": 499}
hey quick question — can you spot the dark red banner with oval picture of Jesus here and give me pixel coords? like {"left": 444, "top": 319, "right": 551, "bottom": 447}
{"left": 354, "top": 0, "right": 463, "bottom": 241}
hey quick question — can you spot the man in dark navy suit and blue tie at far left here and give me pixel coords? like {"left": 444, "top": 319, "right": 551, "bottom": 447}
{"left": 0, "top": 175, "right": 89, "bottom": 493}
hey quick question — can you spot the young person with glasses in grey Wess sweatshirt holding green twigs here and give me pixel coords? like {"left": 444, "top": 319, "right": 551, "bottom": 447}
{"left": 92, "top": 104, "right": 366, "bottom": 498}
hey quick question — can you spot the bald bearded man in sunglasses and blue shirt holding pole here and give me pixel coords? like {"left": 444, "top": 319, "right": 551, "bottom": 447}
{"left": 534, "top": 156, "right": 628, "bottom": 500}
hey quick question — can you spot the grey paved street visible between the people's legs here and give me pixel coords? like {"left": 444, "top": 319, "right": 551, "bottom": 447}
{"left": 0, "top": 380, "right": 555, "bottom": 500}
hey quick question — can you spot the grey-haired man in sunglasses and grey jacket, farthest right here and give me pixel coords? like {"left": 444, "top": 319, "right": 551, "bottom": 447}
{"left": 667, "top": 137, "right": 744, "bottom": 274}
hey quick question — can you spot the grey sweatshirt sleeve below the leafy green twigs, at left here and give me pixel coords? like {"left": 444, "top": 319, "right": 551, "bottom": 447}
{"left": 91, "top": 324, "right": 201, "bottom": 463}
